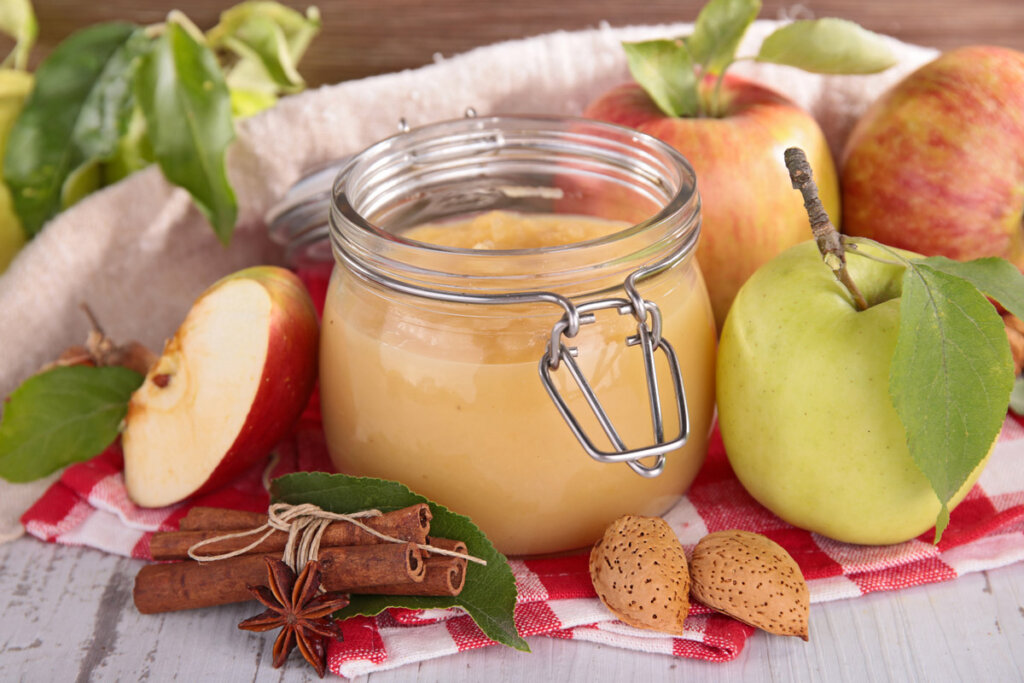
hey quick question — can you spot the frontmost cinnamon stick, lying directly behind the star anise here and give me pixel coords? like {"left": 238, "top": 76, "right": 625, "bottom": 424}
{"left": 133, "top": 543, "right": 426, "bottom": 614}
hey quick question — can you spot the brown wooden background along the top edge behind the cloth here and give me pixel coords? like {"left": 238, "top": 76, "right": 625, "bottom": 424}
{"left": 22, "top": 0, "right": 1024, "bottom": 85}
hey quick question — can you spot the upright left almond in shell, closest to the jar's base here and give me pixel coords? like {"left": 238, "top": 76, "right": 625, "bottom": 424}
{"left": 590, "top": 515, "right": 690, "bottom": 634}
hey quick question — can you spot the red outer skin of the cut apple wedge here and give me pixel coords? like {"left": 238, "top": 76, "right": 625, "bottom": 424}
{"left": 122, "top": 266, "right": 319, "bottom": 507}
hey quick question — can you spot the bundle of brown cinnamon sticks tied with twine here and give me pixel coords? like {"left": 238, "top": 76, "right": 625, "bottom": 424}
{"left": 134, "top": 504, "right": 466, "bottom": 614}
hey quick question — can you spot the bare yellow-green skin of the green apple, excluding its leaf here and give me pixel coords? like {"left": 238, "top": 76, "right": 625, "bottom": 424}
{"left": 717, "top": 242, "right": 991, "bottom": 545}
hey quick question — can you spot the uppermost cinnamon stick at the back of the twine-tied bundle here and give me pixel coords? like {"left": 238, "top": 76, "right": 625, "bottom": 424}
{"left": 150, "top": 503, "right": 431, "bottom": 560}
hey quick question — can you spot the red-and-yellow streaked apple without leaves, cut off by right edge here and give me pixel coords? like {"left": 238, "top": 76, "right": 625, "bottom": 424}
{"left": 843, "top": 46, "right": 1024, "bottom": 270}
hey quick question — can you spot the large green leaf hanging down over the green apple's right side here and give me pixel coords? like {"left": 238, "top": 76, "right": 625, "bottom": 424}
{"left": 889, "top": 261, "right": 1014, "bottom": 542}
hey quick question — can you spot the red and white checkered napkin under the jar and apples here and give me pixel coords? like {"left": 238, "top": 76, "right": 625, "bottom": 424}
{"left": 23, "top": 404, "right": 1024, "bottom": 677}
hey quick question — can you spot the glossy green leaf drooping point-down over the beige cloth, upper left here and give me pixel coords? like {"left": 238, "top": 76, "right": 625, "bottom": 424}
{"left": 135, "top": 23, "right": 238, "bottom": 245}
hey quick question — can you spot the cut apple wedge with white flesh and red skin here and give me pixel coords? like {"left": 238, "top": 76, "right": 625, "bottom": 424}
{"left": 122, "top": 266, "right": 319, "bottom": 507}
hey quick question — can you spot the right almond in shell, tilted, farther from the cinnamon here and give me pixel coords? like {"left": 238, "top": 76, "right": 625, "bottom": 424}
{"left": 690, "top": 529, "right": 810, "bottom": 640}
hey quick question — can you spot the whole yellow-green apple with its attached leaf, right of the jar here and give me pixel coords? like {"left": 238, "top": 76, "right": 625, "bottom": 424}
{"left": 717, "top": 149, "right": 1024, "bottom": 544}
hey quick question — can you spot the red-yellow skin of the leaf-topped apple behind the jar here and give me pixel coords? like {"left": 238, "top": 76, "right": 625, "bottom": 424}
{"left": 584, "top": 74, "right": 840, "bottom": 330}
